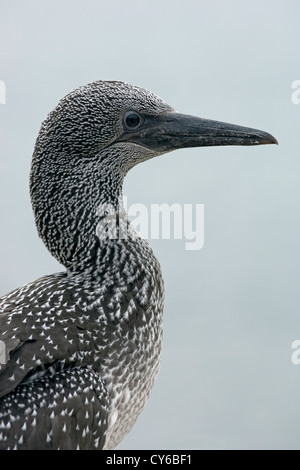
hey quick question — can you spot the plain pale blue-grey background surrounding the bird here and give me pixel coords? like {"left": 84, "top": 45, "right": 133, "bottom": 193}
{"left": 0, "top": 0, "right": 300, "bottom": 449}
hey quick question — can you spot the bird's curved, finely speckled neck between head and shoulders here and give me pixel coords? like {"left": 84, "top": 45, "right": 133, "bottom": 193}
{"left": 30, "top": 151, "right": 137, "bottom": 273}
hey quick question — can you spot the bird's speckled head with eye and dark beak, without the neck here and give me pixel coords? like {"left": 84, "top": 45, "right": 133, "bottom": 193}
{"left": 37, "top": 81, "right": 277, "bottom": 167}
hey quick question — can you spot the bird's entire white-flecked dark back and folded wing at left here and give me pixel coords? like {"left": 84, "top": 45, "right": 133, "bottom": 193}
{"left": 0, "top": 273, "right": 115, "bottom": 449}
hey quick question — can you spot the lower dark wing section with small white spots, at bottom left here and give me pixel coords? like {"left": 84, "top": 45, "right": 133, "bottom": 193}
{"left": 0, "top": 367, "right": 109, "bottom": 450}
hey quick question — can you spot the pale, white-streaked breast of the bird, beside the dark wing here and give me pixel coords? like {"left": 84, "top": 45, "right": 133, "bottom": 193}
{"left": 94, "top": 241, "right": 164, "bottom": 449}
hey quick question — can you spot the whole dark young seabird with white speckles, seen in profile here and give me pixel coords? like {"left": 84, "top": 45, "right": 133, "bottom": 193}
{"left": 0, "top": 80, "right": 277, "bottom": 450}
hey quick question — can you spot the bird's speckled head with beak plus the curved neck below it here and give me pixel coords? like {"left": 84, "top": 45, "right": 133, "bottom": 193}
{"left": 30, "top": 81, "right": 276, "bottom": 271}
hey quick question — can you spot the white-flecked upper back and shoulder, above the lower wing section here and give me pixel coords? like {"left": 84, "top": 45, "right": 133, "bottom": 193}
{"left": 0, "top": 273, "right": 96, "bottom": 397}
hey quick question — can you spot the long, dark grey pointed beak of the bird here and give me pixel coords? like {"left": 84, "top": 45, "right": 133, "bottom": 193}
{"left": 118, "top": 113, "right": 277, "bottom": 153}
